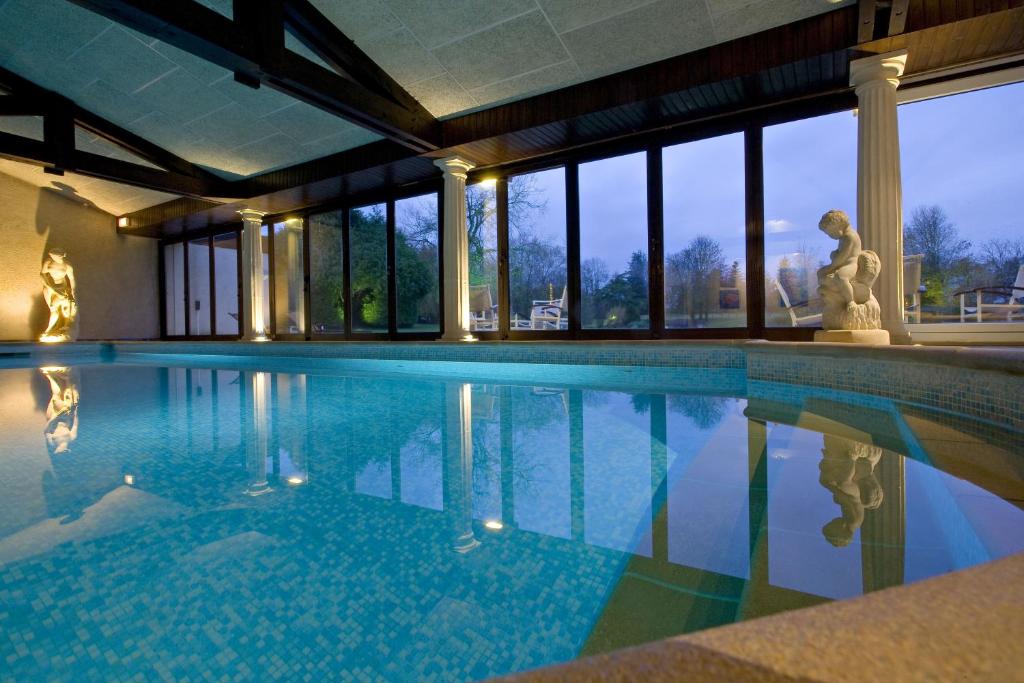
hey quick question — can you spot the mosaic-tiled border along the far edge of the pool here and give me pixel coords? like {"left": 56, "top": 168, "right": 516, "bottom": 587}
{"left": 0, "top": 341, "right": 1024, "bottom": 431}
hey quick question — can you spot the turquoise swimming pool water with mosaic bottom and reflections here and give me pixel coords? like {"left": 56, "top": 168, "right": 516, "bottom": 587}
{"left": 0, "top": 356, "right": 1024, "bottom": 681}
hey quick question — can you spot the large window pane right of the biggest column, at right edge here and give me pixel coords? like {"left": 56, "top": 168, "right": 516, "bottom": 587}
{"left": 901, "top": 83, "right": 1024, "bottom": 323}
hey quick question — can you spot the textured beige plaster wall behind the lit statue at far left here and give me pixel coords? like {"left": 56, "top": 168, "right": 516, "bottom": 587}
{"left": 0, "top": 173, "right": 160, "bottom": 341}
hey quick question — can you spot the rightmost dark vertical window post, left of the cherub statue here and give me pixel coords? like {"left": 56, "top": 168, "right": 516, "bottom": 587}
{"left": 743, "top": 126, "right": 765, "bottom": 338}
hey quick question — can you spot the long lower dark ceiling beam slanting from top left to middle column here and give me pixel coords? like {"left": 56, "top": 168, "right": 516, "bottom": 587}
{"left": 59, "top": 0, "right": 439, "bottom": 153}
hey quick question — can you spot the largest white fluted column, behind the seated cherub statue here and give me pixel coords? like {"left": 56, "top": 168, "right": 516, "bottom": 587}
{"left": 850, "top": 50, "right": 910, "bottom": 343}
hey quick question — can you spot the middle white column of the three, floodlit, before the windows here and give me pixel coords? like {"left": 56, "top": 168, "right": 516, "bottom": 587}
{"left": 434, "top": 157, "right": 475, "bottom": 341}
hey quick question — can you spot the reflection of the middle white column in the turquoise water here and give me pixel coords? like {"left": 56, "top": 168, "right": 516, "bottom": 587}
{"left": 442, "top": 382, "right": 480, "bottom": 553}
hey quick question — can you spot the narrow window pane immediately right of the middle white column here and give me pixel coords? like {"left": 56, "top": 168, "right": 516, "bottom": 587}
{"left": 466, "top": 180, "right": 498, "bottom": 331}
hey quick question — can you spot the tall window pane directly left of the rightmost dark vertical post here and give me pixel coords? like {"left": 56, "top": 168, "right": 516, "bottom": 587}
{"left": 662, "top": 133, "right": 746, "bottom": 329}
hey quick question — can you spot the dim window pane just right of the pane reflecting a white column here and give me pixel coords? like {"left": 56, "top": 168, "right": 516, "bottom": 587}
{"left": 309, "top": 211, "right": 345, "bottom": 335}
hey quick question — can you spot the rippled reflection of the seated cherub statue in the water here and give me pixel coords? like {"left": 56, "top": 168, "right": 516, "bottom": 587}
{"left": 818, "top": 434, "right": 883, "bottom": 548}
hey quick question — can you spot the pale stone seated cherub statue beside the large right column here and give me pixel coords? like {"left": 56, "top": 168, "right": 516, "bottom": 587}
{"left": 818, "top": 209, "right": 882, "bottom": 330}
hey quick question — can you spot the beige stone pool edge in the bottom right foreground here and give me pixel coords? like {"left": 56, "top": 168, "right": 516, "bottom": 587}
{"left": 506, "top": 554, "right": 1024, "bottom": 683}
